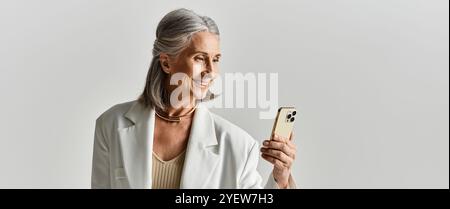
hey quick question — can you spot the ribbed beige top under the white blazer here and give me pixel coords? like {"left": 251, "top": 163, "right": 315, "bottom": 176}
{"left": 152, "top": 150, "right": 186, "bottom": 189}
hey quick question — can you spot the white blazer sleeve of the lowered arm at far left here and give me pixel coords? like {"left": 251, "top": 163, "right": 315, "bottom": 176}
{"left": 91, "top": 116, "right": 111, "bottom": 189}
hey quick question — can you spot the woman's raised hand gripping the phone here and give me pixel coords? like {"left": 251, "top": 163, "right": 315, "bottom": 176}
{"left": 261, "top": 133, "right": 297, "bottom": 188}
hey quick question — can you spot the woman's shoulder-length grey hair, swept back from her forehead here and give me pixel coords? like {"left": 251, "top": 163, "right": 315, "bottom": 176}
{"left": 138, "top": 9, "right": 220, "bottom": 109}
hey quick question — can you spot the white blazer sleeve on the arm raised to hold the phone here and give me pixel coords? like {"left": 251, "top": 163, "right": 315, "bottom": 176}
{"left": 239, "top": 141, "right": 297, "bottom": 189}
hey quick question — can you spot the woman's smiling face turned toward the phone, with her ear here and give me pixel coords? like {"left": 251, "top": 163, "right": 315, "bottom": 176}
{"left": 160, "top": 32, "right": 221, "bottom": 104}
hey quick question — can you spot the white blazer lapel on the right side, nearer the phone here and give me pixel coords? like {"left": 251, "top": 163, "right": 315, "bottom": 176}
{"left": 180, "top": 103, "right": 219, "bottom": 189}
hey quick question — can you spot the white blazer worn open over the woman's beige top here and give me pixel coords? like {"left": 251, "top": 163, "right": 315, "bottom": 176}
{"left": 91, "top": 101, "right": 296, "bottom": 189}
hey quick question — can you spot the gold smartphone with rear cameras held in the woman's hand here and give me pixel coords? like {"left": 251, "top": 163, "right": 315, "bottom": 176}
{"left": 272, "top": 107, "right": 297, "bottom": 139}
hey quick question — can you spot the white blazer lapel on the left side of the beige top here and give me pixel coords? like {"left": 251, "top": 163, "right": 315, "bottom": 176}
{"left": 118, "top": 102, "right": 155, "bottom": 189}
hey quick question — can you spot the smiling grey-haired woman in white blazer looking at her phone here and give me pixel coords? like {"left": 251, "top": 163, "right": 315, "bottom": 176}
{"left": 92, "top": 9, "right": 296, "bottom": 188}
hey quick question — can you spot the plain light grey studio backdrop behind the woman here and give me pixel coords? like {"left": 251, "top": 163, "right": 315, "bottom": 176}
{"left": 0, "top": 0, "right": 449, "bottom": 188}
